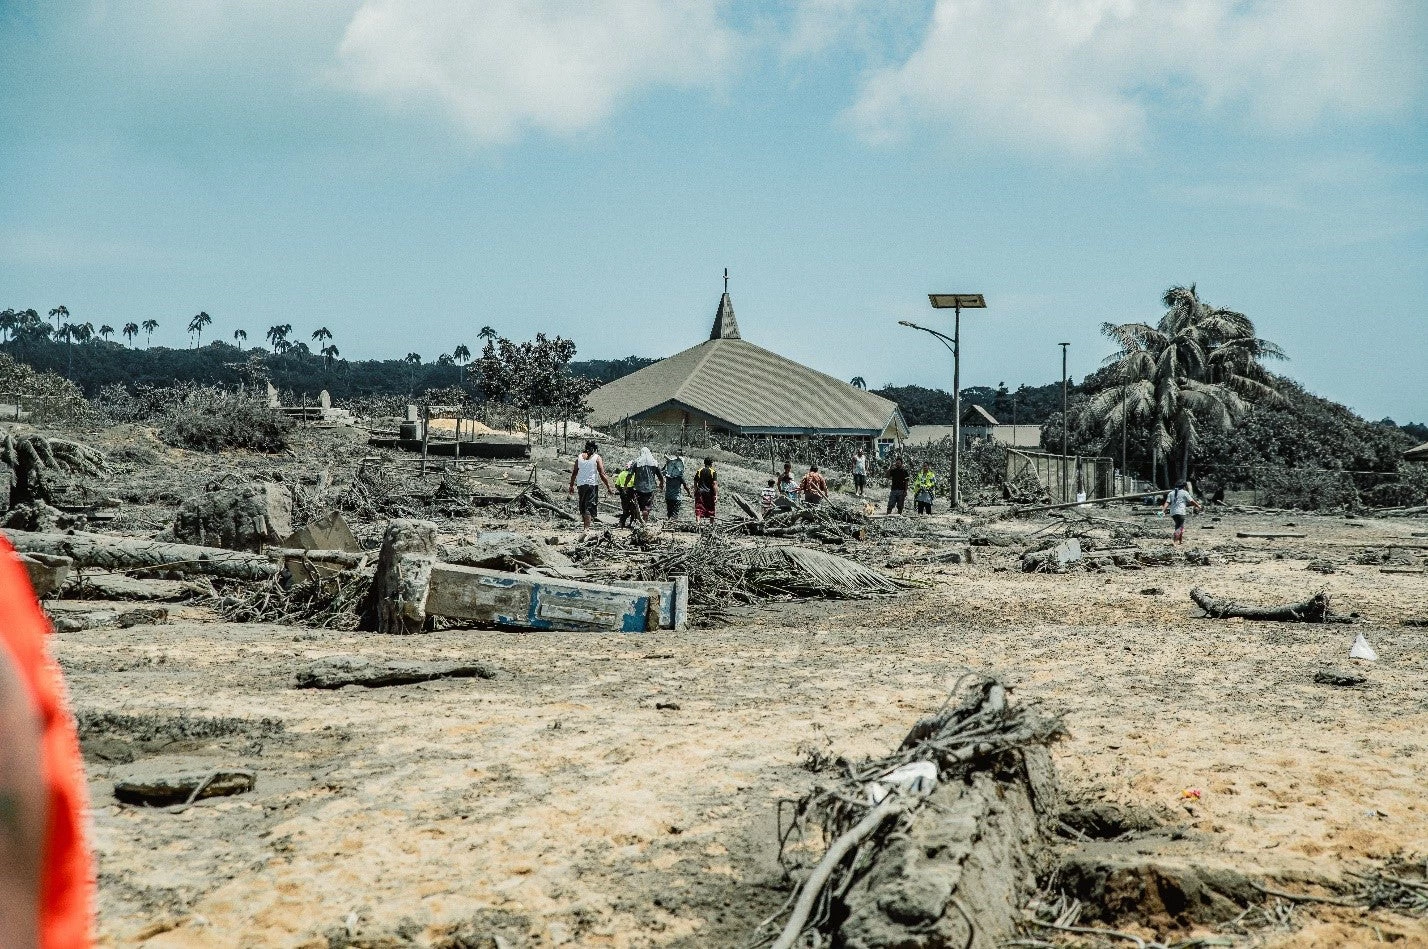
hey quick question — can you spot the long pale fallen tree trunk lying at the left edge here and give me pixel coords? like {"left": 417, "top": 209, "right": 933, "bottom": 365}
{"left": 4, "top": 531, "right": 278, "bottom": 581}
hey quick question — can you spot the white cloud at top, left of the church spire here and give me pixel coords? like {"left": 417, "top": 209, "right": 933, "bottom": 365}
{"left": 329, "top": 0, "right": 737, "bottom": 143}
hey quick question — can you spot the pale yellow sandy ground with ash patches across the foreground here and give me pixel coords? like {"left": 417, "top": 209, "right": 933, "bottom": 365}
{"left": 56, "top": 515, "right": 1428, "bottom": 948}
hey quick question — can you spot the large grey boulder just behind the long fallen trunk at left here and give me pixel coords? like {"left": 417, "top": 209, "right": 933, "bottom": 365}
{"left": 173, "top": 482, "right": 293, "bottom": 554}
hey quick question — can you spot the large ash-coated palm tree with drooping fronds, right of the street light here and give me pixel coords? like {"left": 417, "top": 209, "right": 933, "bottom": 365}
{"left": 1090, "top": 284, "right": 1285, "bottom": 478}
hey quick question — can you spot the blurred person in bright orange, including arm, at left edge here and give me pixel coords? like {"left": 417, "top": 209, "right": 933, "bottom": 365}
{"left": 0, "top": 538, "right": 94, "bottom": 949}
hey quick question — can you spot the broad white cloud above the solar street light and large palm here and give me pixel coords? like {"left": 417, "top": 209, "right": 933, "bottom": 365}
{"left": 848, "top": 0, "right": 1425, "bottom": 154}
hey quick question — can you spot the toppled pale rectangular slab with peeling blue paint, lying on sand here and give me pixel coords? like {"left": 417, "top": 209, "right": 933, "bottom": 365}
{"left": 427, "top": 564, "right": 658, "bottom": 632}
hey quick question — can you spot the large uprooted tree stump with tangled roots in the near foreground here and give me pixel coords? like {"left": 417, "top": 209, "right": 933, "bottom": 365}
{"left": 757, "top": 679, "right": 1061, "bottom": 949}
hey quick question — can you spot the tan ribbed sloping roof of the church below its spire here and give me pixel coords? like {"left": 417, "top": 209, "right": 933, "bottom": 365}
{"left": 588, "top": 335, "right": 905, "bottom": 435}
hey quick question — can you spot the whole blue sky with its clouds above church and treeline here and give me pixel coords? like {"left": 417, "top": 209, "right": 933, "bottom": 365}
{"left": 0, "top": 0, "right": 1428, "bottom": 421}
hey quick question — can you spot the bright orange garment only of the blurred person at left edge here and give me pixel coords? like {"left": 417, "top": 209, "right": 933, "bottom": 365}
{"left": 0, "top": 538, "right": 94, "bottom": 949}
